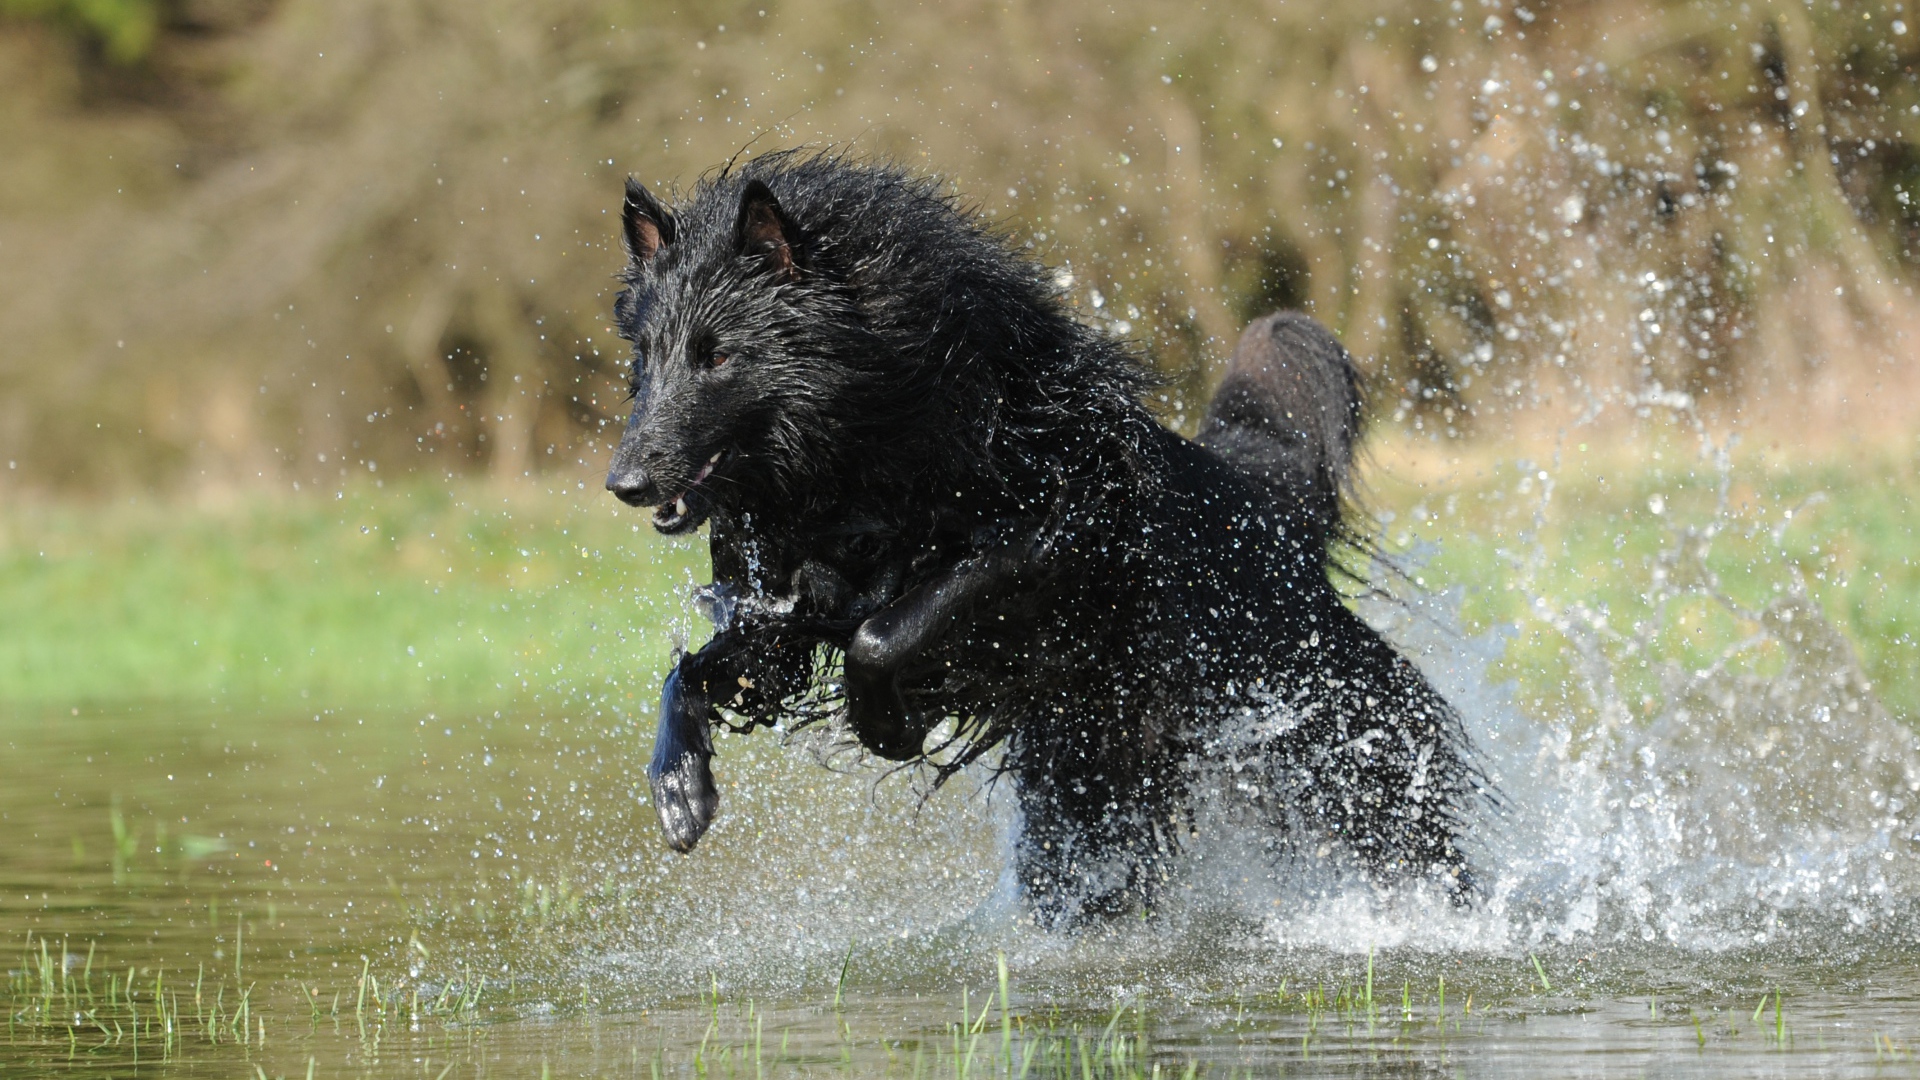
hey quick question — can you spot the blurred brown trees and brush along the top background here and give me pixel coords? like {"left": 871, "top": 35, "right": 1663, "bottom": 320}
{"left": 0, "top": 0, "right": 1920, "bottom": 488}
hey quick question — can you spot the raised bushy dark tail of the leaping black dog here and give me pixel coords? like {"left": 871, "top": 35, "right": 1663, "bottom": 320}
{"left": 1198, "top": 311, "right": 1361, "bottom": 544}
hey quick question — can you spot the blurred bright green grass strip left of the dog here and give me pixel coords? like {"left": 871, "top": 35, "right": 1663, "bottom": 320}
{"left": 0, "top": 474, "right": 705, "bottom": 709}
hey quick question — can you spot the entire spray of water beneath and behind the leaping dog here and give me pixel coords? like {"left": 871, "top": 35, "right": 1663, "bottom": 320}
{"left": 428, "top": 443, "right": 1920, "bottom": 999}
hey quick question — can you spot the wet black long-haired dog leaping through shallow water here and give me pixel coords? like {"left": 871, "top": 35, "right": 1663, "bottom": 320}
{"left": 607, "top": 154, "right": 1480, "bottom": 924}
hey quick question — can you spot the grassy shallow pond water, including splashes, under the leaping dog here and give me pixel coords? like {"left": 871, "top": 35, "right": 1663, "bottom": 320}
{"left": 11, "top": 630, "right": 1920, "bottom": 1078}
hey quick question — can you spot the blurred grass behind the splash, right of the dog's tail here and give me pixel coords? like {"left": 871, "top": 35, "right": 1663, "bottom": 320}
{"left": 1375, "top": 434, "right": 1920, "bottom": 717}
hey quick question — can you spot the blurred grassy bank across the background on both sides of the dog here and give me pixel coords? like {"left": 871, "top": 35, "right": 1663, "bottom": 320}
{"left": 0, "top": 444, "right": 1920, "bottom": 715}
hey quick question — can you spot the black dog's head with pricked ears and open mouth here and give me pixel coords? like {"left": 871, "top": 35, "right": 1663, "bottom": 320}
{"left": 607, "top": 173, "right": 862, "bottom": 532}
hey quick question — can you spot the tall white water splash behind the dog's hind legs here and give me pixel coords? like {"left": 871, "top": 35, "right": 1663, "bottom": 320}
{"left": 1328, "top": 474, "right": 1920, "bottom": 951}
